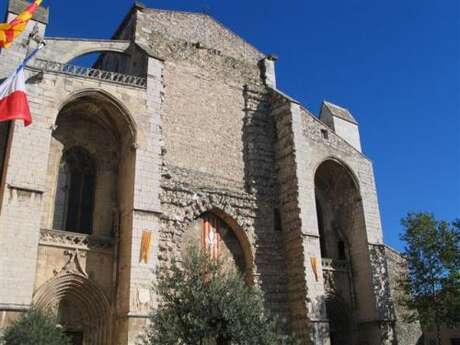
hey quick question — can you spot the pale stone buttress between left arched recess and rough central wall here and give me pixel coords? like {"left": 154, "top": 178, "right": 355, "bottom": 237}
{"left": 120, "top": 57, "right": 163, "bottom": 345}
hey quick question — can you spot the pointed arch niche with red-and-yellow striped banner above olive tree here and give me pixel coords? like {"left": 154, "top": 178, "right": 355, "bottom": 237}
{"left": 181, "top": 212, "right": 252, "bottom": 283}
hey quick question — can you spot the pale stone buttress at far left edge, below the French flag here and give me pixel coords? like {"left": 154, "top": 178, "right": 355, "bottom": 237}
{"left": 0, "top": 75, "right": 51, "bottom": 311}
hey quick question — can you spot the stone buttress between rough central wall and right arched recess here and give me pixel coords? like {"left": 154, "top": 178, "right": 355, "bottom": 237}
{"left": 272, "top": 95, "right": 329, "bottom": 345}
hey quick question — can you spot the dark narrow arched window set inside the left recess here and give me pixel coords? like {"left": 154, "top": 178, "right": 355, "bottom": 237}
{"left": 53, "top": 147, "right": 96, "bottom": 234}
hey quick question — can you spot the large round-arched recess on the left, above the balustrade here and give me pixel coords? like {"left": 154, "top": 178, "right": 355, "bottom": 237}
{"left": 45, "top": 90, "right": 136, "bottom": 237}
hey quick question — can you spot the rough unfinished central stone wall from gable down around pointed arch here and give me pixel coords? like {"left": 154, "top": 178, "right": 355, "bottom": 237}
{"left": 136, "top": 10, "right": 287, "bottom": 319}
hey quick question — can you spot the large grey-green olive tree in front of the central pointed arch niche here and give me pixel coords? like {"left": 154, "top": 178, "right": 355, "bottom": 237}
{"left": 139, "top": 247, "right": 294, "bottom": 345}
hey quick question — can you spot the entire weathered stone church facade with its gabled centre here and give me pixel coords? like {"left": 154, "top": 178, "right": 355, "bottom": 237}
{"left": 0, "top": 0, "right": 410, "bottom": 345}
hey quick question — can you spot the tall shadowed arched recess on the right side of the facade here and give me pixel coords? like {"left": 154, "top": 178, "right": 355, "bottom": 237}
{"left": 315, "top": 159, "right": 367, "bottom": 345}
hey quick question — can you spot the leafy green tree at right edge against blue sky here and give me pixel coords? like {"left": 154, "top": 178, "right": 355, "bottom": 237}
{"left": 401, "top": 212, "right": 460, "bottom": 344}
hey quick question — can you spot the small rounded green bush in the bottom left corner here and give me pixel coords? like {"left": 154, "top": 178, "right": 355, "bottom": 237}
{"left": 0, "top": 308, "right": 70, "bottom": 345}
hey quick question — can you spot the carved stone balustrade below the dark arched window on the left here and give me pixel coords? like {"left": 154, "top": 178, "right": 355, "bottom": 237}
{"left": 40, "top": 229, "right": 113, "bottom": 251}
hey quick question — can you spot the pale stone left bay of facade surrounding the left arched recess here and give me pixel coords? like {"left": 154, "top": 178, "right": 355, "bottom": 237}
{"left": 0, "top": 3, "right": 162, "bottom": 343}
